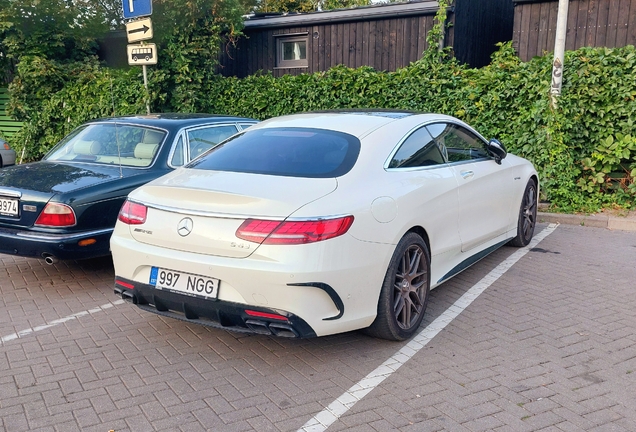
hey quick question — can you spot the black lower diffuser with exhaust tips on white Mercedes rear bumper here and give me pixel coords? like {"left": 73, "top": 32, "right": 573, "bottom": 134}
{"left": 115, "top": 277, "right": 316, "bottom": 338}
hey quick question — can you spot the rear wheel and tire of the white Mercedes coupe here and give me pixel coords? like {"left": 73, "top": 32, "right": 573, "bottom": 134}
{"left": 366, "top": 233, "right": 431, "bottom": 341}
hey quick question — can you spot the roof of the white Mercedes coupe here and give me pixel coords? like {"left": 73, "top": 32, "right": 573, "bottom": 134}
{"left": 252, "top": 109, "right": 464, "bottom": 139}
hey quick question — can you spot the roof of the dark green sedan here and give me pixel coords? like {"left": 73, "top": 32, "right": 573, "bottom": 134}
{"left": 87, "top": 113, "right": 257, "bottom": 129}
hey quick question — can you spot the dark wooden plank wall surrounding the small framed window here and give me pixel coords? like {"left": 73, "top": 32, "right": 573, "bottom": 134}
{"left": 219, "top": 15, "right": 440, "bottom": 78}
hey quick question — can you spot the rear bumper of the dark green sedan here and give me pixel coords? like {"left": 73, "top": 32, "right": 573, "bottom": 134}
{"left": 0, "top": 228, "right": 113, "bottom": 260}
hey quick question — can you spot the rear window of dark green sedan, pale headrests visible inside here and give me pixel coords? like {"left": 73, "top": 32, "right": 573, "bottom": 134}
{"left": 44, "top": 123, "right": 166, "bottom": 167}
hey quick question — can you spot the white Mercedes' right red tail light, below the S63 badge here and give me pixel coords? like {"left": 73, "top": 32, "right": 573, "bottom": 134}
{"left": 236, "top": 216, "right": 353, "bottom": 245}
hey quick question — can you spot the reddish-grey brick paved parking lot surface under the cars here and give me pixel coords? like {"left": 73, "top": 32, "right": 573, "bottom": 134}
{"left": 0, "top": 224, "right": 636, "bottom": 432}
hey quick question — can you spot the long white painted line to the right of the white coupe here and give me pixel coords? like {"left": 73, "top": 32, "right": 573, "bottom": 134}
{"left": 298, "top": 224, "right": 559, "bottom": 432}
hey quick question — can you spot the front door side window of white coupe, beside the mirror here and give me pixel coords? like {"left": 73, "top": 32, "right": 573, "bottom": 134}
{"left": 426, "top": 123, "right": 488, "bottom": 162}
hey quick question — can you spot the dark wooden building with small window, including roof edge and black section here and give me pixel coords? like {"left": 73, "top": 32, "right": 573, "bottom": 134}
{"left": 218, "top": 0, "right": 513, "bottom": 77}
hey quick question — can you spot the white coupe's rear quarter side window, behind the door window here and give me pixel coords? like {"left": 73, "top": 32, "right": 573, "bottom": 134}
{"left": 389, "top": 127, "right": 445, "bottom": 168}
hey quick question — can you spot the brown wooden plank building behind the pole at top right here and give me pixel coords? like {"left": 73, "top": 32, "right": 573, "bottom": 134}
{"left": 513, "top": 0, "right": 636, "bottom": 61}
